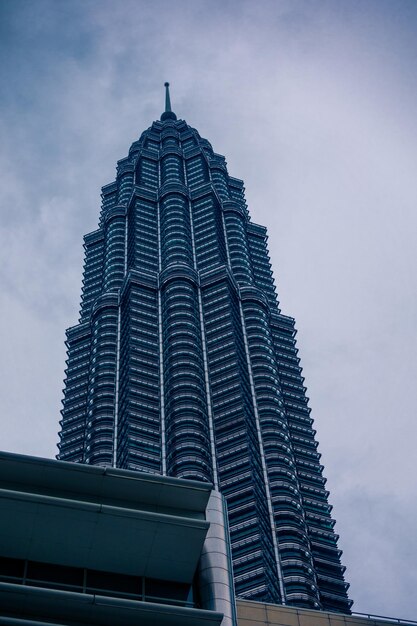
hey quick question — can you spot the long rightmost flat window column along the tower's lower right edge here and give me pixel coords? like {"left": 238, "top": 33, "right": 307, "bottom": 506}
{"left": 272, "top": 315, "right": 351, "bottom": 611}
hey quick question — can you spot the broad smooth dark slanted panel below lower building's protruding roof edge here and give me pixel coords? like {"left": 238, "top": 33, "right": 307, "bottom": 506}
{"left": 0, "top": 491, "right": 209, "bottom": 582}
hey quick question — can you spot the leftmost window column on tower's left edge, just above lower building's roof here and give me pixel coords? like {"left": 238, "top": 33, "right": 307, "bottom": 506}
{"left": 57, "top": 324, "right": 91, "bottom": 463}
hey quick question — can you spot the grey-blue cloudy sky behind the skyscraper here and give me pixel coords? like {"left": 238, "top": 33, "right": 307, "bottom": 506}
{"left": 0, "top": 0, "right": 417, "bottom": 619}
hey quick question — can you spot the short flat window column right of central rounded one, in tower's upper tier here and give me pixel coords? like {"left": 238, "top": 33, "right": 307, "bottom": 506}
{"left": 192, "top": 194, "right": 227, "bottom": 271}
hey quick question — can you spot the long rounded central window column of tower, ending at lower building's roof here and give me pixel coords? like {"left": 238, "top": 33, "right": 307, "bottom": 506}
{"left": 162, "top": 276, "right": 213, "bottom": 482}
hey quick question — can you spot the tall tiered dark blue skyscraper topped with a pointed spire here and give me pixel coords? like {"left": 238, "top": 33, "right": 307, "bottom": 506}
{"left": 58, "top": 83, "right": 351, "bottom": 612}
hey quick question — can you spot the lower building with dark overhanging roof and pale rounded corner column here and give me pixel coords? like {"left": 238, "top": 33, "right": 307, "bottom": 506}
{"left": 0, "top": 453, "right": 236, "bottom": 626}
